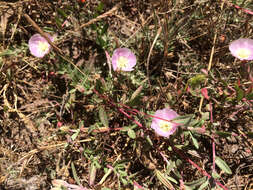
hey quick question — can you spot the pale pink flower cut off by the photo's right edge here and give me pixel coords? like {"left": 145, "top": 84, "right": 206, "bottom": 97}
{"left": 229, "top": 38, "right": 253, "bottom": 60}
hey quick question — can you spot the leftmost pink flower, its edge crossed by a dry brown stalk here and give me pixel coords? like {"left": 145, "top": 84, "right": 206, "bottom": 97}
{"left": 28, "top": 34, "right": 53, "bottom": 58}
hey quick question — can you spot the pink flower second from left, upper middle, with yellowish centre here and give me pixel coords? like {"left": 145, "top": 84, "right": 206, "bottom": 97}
{"left": 112, "top": 48, "right": 136, "bottom": 71}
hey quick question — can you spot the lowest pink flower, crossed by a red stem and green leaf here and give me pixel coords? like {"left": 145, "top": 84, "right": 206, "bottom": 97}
{"left": 151, "top": 108, "right": 180, "bottom": 138}
